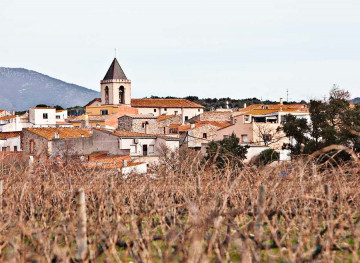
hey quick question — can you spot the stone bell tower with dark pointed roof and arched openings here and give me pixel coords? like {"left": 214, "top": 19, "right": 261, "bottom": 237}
{"left": 100, "top": 58, "right": 131, "bottom": 106}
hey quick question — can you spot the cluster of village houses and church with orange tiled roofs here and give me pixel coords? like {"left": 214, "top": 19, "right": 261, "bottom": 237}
{"left": 0, "top": 58, "right": 310, "bottom": 174}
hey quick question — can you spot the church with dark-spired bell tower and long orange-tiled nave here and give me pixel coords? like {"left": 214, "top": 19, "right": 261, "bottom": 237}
{"left": 86, "top": 58, "right": 204, "bottom": 122}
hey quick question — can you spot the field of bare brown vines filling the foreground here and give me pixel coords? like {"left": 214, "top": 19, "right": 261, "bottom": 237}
{"left": 0, "top": 154, "right": 360, "bottom": 262}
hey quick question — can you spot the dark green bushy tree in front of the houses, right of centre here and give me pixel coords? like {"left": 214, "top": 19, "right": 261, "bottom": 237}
{"left": 206, "top": 133, "right": 248, "bottom": 168}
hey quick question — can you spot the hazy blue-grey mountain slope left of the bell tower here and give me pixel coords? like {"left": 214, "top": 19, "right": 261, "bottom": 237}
{"left": 0, "top": 67, "right": 100, "bottom": 110}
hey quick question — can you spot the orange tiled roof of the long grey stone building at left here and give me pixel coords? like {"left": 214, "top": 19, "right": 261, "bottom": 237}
{"left": 24, "top": 128, "right": 91, "bottom": 141}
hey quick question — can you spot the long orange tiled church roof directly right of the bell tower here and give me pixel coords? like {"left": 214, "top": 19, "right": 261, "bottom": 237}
{"left": 131, "top": 99, "right": 204, "bottom": 108}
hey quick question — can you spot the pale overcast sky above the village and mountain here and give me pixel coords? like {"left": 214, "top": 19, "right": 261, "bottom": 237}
{"left": 0, "top": 0, "right": 360, "bottom": 100}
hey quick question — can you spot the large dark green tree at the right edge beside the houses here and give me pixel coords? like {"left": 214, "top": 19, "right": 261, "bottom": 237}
{"left": 283, "top": 86, "right": 360, "bottom": 160}
